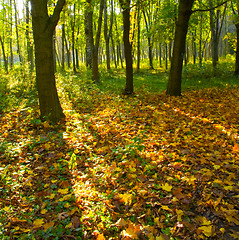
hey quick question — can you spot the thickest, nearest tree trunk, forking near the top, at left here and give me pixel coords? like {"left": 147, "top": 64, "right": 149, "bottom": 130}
{"left": 31, "top": 0, "right": 65, "bottom": 122}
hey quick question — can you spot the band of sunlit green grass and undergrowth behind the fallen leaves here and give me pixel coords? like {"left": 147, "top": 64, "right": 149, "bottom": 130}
{"left": 0, "top": 56, "right": 239, "bottom": 113}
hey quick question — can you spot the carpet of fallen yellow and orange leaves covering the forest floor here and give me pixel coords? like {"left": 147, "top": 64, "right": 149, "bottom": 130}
{"left": 0, "top": 62, "right": 239, "bottom": 240}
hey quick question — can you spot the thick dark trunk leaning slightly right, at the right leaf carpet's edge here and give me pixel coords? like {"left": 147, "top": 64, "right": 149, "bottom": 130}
{"left": 167, "top": 0, "right": 194, "bottom": 96}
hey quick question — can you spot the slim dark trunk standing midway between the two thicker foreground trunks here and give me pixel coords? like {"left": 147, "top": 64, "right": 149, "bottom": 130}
{"left": 120, "top": 0, "right": 134, "bottom": 94}
